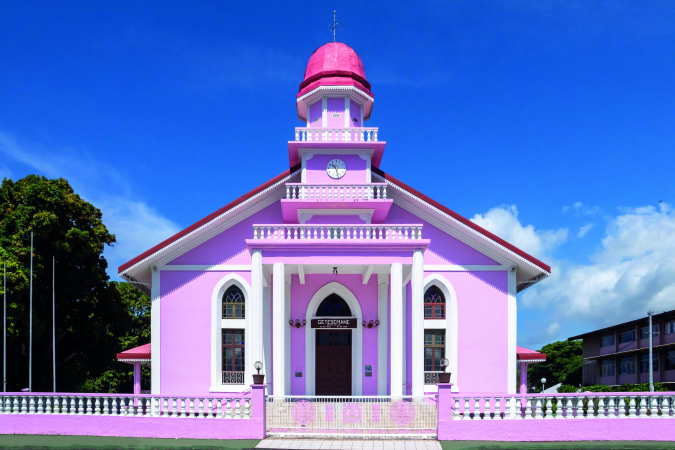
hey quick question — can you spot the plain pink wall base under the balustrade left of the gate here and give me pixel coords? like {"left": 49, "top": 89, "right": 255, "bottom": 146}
{"left": 0, "top": 414, "right": 265, "bottom": 439}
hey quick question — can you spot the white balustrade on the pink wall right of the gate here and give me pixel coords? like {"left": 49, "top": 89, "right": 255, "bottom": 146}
{"left": 451, "top": 392, "right": 675, "bottom": 420}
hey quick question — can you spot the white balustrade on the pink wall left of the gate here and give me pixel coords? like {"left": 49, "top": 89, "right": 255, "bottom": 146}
{"left": 0, "top": 393, "right": 251, "bottom": 419}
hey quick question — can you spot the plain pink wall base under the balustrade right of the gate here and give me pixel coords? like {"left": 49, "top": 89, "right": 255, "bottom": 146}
{"left": 438, "top": 418, "right": 675, "bottom": 442}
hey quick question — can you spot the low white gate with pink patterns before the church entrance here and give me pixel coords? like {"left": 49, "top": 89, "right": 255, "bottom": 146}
{"left": 266, "top": 396, "right": 438, "bottom": 436}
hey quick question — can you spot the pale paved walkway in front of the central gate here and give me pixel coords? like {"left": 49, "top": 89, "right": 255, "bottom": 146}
{"left": 256, "top": 438, "right": 441, "bottom": 450}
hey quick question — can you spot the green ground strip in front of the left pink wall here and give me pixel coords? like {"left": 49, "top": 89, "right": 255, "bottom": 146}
{"left": 0, "top": 434, "right": 260, "bottom": 450}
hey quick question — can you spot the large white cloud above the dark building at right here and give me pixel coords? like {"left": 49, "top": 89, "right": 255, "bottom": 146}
{"left": 523, "top": 204, "right": 675, "bottom": 327}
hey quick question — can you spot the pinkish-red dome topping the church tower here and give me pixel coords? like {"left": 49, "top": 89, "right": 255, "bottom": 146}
{"left": 298, "top": 42, "right": 373, "bottom": 97}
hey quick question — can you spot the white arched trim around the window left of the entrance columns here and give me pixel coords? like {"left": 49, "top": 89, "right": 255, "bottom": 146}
{"left": 209, "top": 273, "right": 252, "bottom": 392}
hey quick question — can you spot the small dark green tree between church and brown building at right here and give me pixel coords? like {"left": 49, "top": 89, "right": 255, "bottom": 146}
{"left": 527, "top": 341, "right": 583, "bottom": 392}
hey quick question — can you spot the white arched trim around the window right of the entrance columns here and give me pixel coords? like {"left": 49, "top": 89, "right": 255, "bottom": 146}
{"left": 424, "top": 273, "right": 460, "bottom": 392}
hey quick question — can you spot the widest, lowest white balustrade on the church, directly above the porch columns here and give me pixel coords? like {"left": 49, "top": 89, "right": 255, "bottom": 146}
{"left": 253, "top": 224, "right": 422, "bottom": 241}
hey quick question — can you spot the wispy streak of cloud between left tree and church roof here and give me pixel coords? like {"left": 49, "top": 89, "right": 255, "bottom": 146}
{"left": 0, "top": 132, "right": 180, "bottom": 279}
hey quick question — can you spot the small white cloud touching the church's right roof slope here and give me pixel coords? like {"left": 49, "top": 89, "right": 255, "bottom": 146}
{"left": 471, "top": 205, "right": 568, "bottom": 258}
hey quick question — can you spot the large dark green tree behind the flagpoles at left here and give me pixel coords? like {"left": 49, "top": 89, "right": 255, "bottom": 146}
{"left": 0, "top": 175, "right": 149, "bottom": 392}
